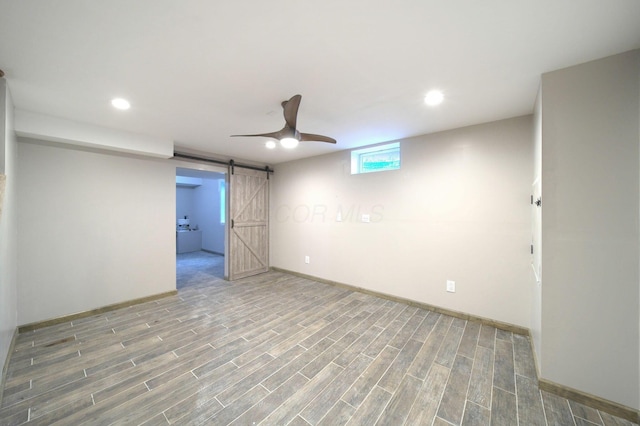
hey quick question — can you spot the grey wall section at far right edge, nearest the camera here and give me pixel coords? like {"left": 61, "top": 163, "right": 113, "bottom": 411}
{"left": 540, "top": 51, "right": 640, "bottom": 409}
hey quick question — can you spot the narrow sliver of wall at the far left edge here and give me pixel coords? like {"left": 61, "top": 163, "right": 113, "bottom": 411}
{"left": 0, "top": 78, "right": 18, "bottom": 382}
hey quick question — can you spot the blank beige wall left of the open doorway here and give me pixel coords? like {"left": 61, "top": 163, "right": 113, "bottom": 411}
{"left": 18, "top": 139, "right": 176, "bottom": 325}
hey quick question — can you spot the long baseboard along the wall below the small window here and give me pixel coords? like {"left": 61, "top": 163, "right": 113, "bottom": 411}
{"left": 271, "top": 266, "right": 531, "bottom": 337}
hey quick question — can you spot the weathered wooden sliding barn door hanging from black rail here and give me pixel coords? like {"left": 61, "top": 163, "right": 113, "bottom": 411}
{"left": 228, "top": 167, "right": 269, "bottom": 280}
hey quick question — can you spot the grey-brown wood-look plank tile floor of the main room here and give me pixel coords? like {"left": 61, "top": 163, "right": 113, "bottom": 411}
{"left": 0, "top": 272, "right": 632, "bottom": 426}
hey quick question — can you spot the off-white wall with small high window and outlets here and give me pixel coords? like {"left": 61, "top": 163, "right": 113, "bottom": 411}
{"left": 270, "top": 116, "right": 533, "bottom": 327}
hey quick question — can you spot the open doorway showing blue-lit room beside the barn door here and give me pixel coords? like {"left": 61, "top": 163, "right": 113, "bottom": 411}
{"left": 176, "top": 167, "right": 227, "bottom": 289}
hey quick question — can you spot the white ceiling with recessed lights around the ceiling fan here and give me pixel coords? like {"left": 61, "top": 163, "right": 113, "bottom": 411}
{"left": 0, "top": 0, "right": 640, "bottom": 164}
